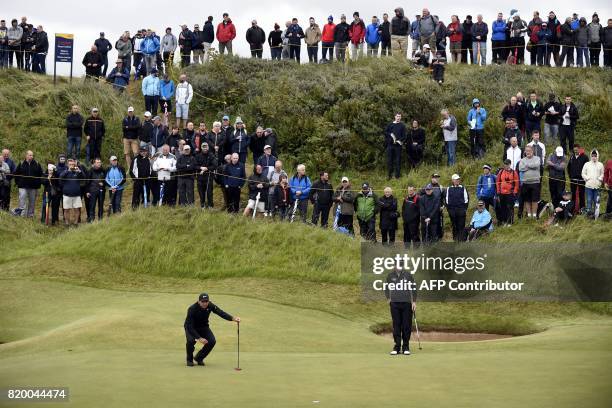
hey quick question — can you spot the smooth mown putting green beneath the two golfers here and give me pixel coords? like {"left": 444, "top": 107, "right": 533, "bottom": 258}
{"left": 0, "top": 279, "right": 612, "bottom": 407}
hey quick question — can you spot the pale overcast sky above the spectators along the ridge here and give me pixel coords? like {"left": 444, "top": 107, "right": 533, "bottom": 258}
{"left": 5, "top": 0, "right": 612, "bottom": 75}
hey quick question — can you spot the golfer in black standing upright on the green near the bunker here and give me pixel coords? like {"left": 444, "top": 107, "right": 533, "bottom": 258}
{"left": 385, "top": 270, "right": 416, "bottom": 356}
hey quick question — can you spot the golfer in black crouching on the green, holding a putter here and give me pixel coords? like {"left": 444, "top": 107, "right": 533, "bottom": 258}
{"left": 185, "top": 293, "right": 240, "bottom": 367}
